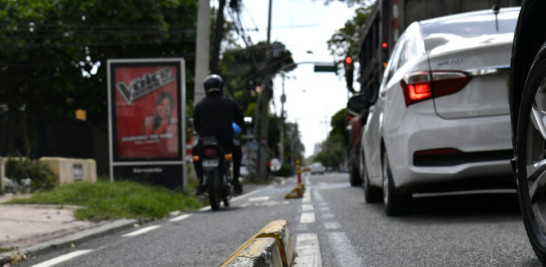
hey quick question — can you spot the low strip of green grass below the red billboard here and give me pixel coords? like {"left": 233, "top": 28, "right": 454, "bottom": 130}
{"left": 9, "top": 181, "right": 201, "bottom": 221}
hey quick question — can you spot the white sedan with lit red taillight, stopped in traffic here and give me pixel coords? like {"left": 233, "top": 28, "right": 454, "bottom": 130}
{"left": 361, "top": 8, "right": 519, "bottom": 215}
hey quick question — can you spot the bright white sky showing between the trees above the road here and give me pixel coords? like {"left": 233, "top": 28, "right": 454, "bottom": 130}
{"left": 235, "top": 0, "right": 355, "bottom": 157}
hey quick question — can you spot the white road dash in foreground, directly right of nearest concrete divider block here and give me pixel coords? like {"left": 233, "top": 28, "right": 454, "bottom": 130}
{"left": 292, "top": 234, "right": 322, "bottom": 267}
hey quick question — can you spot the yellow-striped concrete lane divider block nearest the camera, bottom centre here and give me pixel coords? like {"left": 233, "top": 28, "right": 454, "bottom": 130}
{"left": 221, "top": 220, "right": 294, "bottom": 267}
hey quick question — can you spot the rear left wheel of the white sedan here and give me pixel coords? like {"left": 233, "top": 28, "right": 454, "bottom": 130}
{"left": 383, "top": 152, "right": 411, "bottom": 216}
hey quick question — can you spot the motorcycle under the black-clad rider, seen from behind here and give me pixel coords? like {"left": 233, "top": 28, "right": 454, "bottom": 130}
{"left": 194, "top": 137, "right": 233, "bottom": 210}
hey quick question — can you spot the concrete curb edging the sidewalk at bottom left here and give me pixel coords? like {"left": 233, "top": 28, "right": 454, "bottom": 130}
{"left": 0, "top": 219, "right": 139, "bottom": 265}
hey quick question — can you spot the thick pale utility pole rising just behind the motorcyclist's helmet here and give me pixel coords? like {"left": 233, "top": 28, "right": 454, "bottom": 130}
{"left": 193, "top": 0, "right": 210, "bottom": 104}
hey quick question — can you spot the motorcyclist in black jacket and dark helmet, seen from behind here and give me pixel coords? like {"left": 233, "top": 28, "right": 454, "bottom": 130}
{"left": 193, "top": 74, "right": 246, "bottom": 195}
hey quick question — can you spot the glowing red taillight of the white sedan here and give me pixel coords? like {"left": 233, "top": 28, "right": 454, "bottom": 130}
{"left": 400, "top": 71, "right": 470, "bottom": 106}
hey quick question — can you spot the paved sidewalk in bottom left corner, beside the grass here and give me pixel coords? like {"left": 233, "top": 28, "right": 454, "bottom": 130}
{"left": 0, "top": 194, "right": 137, "bottom": 266}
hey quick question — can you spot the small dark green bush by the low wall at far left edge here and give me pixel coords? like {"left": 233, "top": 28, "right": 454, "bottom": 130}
{"left": 6, "top": 158, "right": 58, "bottom": 192}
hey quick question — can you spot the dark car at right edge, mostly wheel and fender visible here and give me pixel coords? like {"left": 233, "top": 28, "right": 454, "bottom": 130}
{"left": 510, "top": 0, "right": 546, "bottom": 265}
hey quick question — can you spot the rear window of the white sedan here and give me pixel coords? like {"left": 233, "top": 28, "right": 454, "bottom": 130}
{"left": 421, "top": 8, "right": 519, "bottom": 51}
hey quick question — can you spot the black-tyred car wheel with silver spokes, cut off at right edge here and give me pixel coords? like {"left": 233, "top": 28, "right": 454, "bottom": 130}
{"left": 516, "top": 43, "right": 546, "bottom": 264}
